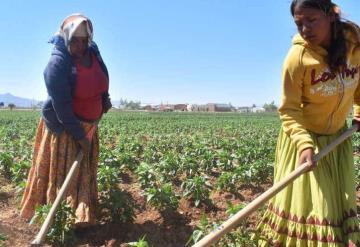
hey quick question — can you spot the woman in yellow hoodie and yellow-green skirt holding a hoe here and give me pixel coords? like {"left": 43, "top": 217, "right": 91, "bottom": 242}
{"left": 257, "top": 0, "right": 360, "bottom": 247}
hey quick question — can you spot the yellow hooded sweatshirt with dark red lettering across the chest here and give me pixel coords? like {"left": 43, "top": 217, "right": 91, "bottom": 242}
{"left": 279, "top": 26, "right": 360, "bottom": 152}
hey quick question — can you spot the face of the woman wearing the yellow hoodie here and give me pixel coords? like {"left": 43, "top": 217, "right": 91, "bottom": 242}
{"left": 294, "top": 7, "right": 332, "bottom": 48}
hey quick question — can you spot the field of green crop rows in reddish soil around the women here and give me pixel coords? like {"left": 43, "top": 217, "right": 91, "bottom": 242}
{"left": 0, "top": 110, "right": 360, "bottom": 247}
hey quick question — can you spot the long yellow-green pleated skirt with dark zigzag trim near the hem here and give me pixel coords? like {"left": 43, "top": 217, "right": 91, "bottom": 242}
{"left": 256, "top": 128, "right": 360, "bottom": 247}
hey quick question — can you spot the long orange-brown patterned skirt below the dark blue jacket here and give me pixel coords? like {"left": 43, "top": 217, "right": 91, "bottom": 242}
{"left": 20, "top": 119, "right": 99, "bottom": 225}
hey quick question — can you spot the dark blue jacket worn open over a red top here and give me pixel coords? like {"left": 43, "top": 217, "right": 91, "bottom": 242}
{"left": 42, "top": 35, "right": 109, "bottom": 140}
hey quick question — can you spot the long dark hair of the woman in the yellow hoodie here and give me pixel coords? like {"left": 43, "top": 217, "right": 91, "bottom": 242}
{"left": 290, "top": 0, "right": 350, "bottom": 72}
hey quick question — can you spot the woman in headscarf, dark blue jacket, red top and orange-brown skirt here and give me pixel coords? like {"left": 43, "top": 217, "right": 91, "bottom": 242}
{"left": 21, "top": 14, "right": 111, "bottom": 227}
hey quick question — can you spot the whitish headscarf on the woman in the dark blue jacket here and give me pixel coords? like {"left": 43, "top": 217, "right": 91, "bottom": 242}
{"left": 59, "top": 13, "right": 93, "bottom": 52}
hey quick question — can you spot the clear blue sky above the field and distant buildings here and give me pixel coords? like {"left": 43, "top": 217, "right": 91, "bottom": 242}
{"left": 0, "top": 0, "right": 360, "bottom": 106}
